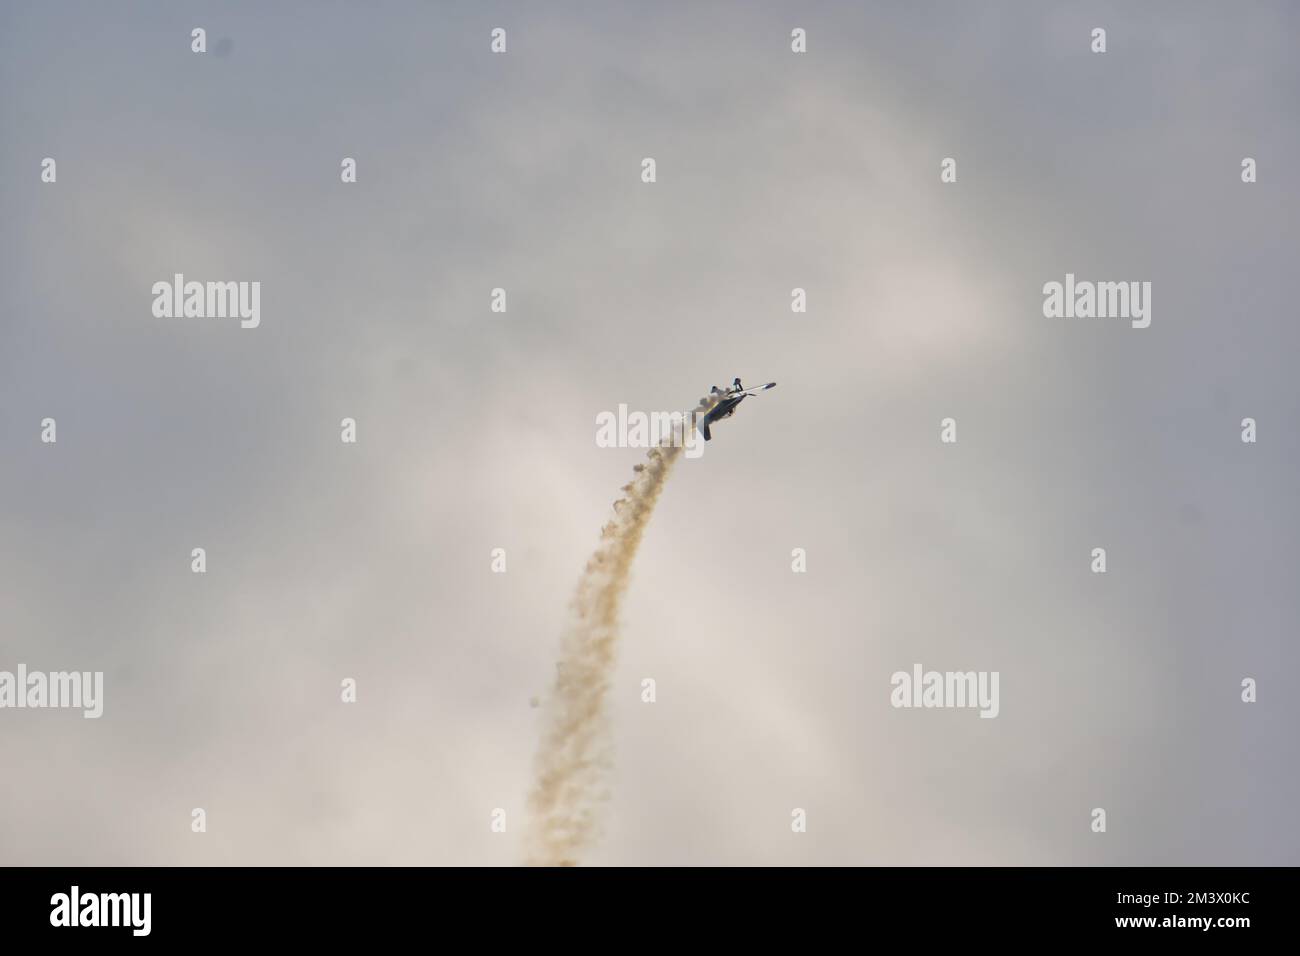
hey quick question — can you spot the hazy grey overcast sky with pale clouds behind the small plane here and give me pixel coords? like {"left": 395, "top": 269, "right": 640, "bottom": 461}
{"left": 0, "top": 0, "right": 1300, "bottom": 865}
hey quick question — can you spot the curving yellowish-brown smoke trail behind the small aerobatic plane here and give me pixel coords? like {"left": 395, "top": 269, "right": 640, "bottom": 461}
{"left": 528, "top": 397, "right": 718, "bottom": 866}
